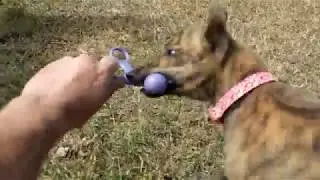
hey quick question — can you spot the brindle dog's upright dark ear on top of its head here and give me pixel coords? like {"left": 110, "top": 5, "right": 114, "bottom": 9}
{"left": 204, "top": 3, "right": 228, "bottom": 57}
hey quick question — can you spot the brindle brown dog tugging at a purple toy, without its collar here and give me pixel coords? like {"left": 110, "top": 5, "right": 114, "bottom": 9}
{"left": 129, "top": 2, "right": 320, "bottom": 180}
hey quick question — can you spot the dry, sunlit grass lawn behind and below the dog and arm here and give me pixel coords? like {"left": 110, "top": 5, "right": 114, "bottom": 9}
{"left": 0, "top": 0, "right": 320, "bottom": 179}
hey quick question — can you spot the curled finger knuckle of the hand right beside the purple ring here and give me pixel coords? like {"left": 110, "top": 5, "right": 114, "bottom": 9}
{"left": 98, "top": 56, "right": 119, "bottom": 76}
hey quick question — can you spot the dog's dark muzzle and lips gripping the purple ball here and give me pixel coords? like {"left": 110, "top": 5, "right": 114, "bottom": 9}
{"left": 126, "top": 69, "right": 180, "bottom": 98}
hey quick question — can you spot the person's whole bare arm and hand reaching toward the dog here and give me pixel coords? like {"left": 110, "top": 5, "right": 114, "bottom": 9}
{"left": 0, "top": 54, "right": 124, "bottom": 180}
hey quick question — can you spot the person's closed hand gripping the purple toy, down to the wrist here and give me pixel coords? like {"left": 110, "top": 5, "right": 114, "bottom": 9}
{"left": 21, "top": 54, "right": 124, "bottom": 131}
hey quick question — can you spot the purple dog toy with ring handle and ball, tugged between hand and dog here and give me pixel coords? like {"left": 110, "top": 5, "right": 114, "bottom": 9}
{"left": 109, "top": 47, "right": 168, "bottom": 96}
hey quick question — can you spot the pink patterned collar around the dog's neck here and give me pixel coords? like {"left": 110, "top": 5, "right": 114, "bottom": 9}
{"left": 209, "top": 72, "right": 276, "bottom": 124}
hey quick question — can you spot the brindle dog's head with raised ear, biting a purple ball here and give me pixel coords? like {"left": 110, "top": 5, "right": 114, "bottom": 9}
{"left": 128, "top": 6, "right": 235, "bottom": 100}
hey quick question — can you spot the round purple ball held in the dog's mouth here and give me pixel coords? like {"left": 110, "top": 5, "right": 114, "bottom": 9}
{"left": 143, "top": 73, "right": 168, "bottom": 95}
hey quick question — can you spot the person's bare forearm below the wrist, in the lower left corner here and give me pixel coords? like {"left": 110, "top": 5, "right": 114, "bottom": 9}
{"left": 0, "top": 96, "right": 64, "bottom": 179}
